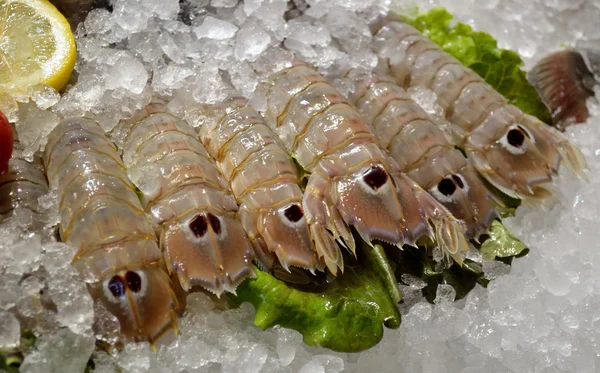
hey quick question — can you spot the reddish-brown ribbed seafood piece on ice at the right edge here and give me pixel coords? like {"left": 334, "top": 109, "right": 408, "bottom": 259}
{"left": 528, "top": 49, "right": 600, "bottom": 128}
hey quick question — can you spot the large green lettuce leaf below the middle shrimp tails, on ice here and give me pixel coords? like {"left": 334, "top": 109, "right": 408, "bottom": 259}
{"left": 237, "top": 240, "right": 402, "bottom": 352}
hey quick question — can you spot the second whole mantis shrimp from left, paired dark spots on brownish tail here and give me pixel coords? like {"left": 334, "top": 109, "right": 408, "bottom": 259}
{"left": 123, "top": 109, "right": 253, "bottom": 296}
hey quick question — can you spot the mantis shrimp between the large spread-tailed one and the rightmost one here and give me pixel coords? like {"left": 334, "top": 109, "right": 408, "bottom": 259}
{"left": 347, "top": 70, "right": 497, "bottom": 237}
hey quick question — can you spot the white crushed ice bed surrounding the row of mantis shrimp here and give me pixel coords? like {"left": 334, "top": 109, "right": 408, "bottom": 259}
{"left": 0, "top": 0, "right": 600, "bottom": 373}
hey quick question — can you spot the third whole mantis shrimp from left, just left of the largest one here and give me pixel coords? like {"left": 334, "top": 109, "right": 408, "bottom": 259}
{"left": 200, "top": 98, "right": 328, "bottom": 274}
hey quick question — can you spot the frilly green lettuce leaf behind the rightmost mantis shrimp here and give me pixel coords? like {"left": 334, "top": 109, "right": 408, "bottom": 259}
{"left": 404, "top": 8, "right": 552, "bottom": 123}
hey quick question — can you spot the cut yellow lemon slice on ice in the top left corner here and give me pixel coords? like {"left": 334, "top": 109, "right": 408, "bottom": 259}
{"left": 0, "top": 0, "right": 77, "bottom": 93}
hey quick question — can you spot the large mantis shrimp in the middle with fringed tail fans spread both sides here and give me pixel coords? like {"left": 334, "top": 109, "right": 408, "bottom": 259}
{"left": 267, "top": 65, "right": 466, "bottom": 264}
